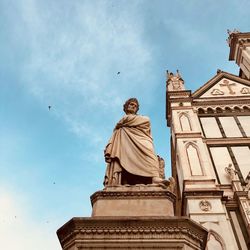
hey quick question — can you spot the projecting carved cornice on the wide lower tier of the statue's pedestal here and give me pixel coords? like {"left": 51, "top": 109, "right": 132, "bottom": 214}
{"left": 57, "top": 217, "right": 207, "bottom": 249}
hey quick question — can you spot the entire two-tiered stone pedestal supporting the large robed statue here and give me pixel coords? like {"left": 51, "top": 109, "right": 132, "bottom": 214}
{"left": 57, "top": 185, "right": 207, "bottom": 250}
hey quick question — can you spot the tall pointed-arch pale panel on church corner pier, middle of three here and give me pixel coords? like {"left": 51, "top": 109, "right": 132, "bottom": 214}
{"left": 186, "top": 142, "right": 203, "bottom": 175}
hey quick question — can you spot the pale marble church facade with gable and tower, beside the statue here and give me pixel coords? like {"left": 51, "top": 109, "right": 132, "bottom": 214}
{"left": 166, "top": 31, "right": 250, "bottom": 250}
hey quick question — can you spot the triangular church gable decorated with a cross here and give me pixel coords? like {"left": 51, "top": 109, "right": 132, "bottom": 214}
{"left": 192, "top": 72, "right": 250, "bottom": 98}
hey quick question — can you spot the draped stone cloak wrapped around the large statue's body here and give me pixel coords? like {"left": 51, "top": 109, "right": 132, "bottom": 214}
{"left": 105, "top": 114, "right": 159, "bottom": 179}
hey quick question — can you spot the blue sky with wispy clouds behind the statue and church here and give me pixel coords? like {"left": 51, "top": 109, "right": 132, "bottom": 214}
{"left": 0, "top": 0, "right": 250, "bottom": 250}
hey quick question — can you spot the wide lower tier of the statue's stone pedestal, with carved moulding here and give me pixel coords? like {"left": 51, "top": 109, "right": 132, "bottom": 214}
{"left": 57, "top": 216, "right": 207, "bottom": 250}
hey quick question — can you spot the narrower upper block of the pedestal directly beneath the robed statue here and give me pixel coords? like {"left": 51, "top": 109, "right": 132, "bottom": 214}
{"left": 91, "top": 184, "right": 175, "bottom": 217}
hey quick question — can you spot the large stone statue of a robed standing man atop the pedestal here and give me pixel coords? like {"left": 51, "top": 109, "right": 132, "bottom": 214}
{"left": 103, "top": 98, "right": 169, "bottom": 186}
